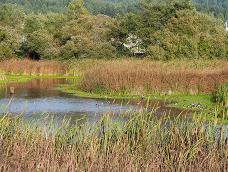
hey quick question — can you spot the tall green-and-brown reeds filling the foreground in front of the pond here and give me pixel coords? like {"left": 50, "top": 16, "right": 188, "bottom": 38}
{"left": 0, "top": 112, "right": 228, "bottom": 172}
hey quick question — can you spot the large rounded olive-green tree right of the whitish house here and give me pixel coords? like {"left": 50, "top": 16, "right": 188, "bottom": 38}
{"left": 151, "top": 10, "right": 227, "bottom": 59}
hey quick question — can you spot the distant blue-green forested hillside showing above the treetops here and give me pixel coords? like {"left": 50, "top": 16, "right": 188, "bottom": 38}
{"left": 0, "top": 0, "right": 228, "bottom": 20}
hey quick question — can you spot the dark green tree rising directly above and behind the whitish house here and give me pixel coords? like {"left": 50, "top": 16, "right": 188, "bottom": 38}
{"left": 112, "top": 0, "right": 191, "bottom": 54}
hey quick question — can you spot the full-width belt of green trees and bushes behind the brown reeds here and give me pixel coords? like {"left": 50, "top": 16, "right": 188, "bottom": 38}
{"left": 0, "top": 0, "right": 228, "bottom": 59}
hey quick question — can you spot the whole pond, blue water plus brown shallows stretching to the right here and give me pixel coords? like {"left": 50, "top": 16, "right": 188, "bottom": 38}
{"left": 0, "top": 79, "right": 227, "bottom": 138}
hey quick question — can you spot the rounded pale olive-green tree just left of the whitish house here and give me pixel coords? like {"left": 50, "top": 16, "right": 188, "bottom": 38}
{"left": 60, "top": 15, "right": 115, "bottom": 59}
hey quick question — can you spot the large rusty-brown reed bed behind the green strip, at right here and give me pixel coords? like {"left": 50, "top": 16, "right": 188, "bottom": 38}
{"left": 79, "top": 60, "right": 228, "bottom": 94}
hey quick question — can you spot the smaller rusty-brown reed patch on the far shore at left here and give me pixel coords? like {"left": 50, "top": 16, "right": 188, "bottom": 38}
{"left": 0, "top": 59, "right": 66, "bottom": 75}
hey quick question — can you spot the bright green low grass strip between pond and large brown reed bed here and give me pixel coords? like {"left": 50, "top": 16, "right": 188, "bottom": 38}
{"left": 56, "top": 84, "right": 228, "bottom": 124}
